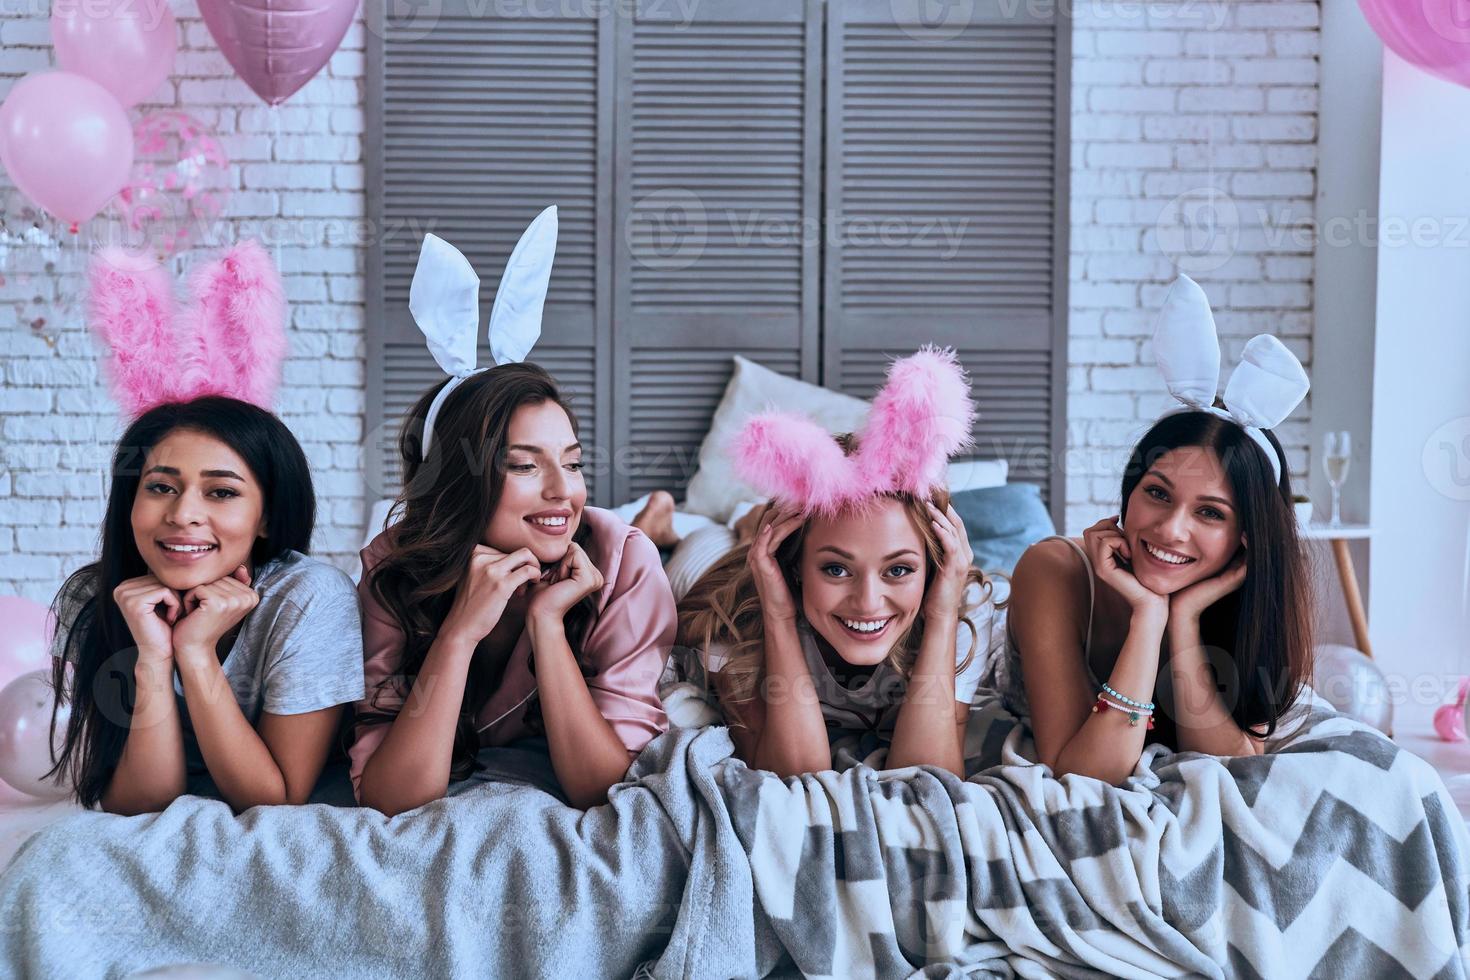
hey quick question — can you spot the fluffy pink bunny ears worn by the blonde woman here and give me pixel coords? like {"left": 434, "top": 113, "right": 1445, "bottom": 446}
{"left": 731, "top": 347, "right": 975, "bottom": 516}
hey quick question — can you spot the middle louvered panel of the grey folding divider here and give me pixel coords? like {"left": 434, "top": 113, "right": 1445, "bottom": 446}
{"left": 602, "top": 0, "right": 822, "bottom": 498}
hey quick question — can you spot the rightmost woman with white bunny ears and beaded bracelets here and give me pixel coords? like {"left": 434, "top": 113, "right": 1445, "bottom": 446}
{"left": 980, "top": 276, "right": 1311, "bottom": 785}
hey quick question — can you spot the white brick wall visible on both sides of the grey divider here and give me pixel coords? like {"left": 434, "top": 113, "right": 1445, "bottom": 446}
{"left": 0, "top": 0, "right": 1319, "bottom": 599}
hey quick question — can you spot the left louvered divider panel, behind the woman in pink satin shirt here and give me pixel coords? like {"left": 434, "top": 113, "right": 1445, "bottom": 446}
{"left": 368, "top": 0, "right": 612, "bottom": 502}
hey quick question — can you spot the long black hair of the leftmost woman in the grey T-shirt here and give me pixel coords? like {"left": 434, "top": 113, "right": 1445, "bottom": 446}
{"left": 47, "top": 395, "right": 316, "bottom": 807}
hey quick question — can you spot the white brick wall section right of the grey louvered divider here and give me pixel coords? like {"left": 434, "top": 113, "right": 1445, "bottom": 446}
{"left": 1064, "top": 0, "right": 1319, "bottom": 533}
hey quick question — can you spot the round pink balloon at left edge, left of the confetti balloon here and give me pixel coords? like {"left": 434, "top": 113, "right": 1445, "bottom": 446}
{"left": 0, "top": 72, "right": 132, "bottom": 225}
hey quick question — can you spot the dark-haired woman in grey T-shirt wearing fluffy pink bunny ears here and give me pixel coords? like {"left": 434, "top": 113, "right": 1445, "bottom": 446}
{"left": 51, "top": 242, "right": 363, "bottom": 814}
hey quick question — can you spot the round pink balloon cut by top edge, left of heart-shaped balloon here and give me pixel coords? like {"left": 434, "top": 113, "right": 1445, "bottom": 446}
{"left": 51, "top": 0, "right": 178, "bottom": 107}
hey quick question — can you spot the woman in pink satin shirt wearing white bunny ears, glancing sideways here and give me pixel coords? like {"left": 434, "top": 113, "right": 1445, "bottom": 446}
{"left": 350, "top": 207, "right": 673, "bottom": 815}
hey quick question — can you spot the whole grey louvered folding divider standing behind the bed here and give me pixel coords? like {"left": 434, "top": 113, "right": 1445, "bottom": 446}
{"left": 366, "top": 0, "right": 1070, "bottom": 523}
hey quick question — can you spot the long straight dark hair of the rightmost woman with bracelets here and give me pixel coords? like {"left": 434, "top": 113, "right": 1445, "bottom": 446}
{"left": 1122, "top": 411, "right": 1311, "bottom": 736}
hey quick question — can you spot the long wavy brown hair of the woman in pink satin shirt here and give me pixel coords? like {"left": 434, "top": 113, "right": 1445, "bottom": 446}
{"left": 359, "top": 363, "right": 597, "bottom": 779}
